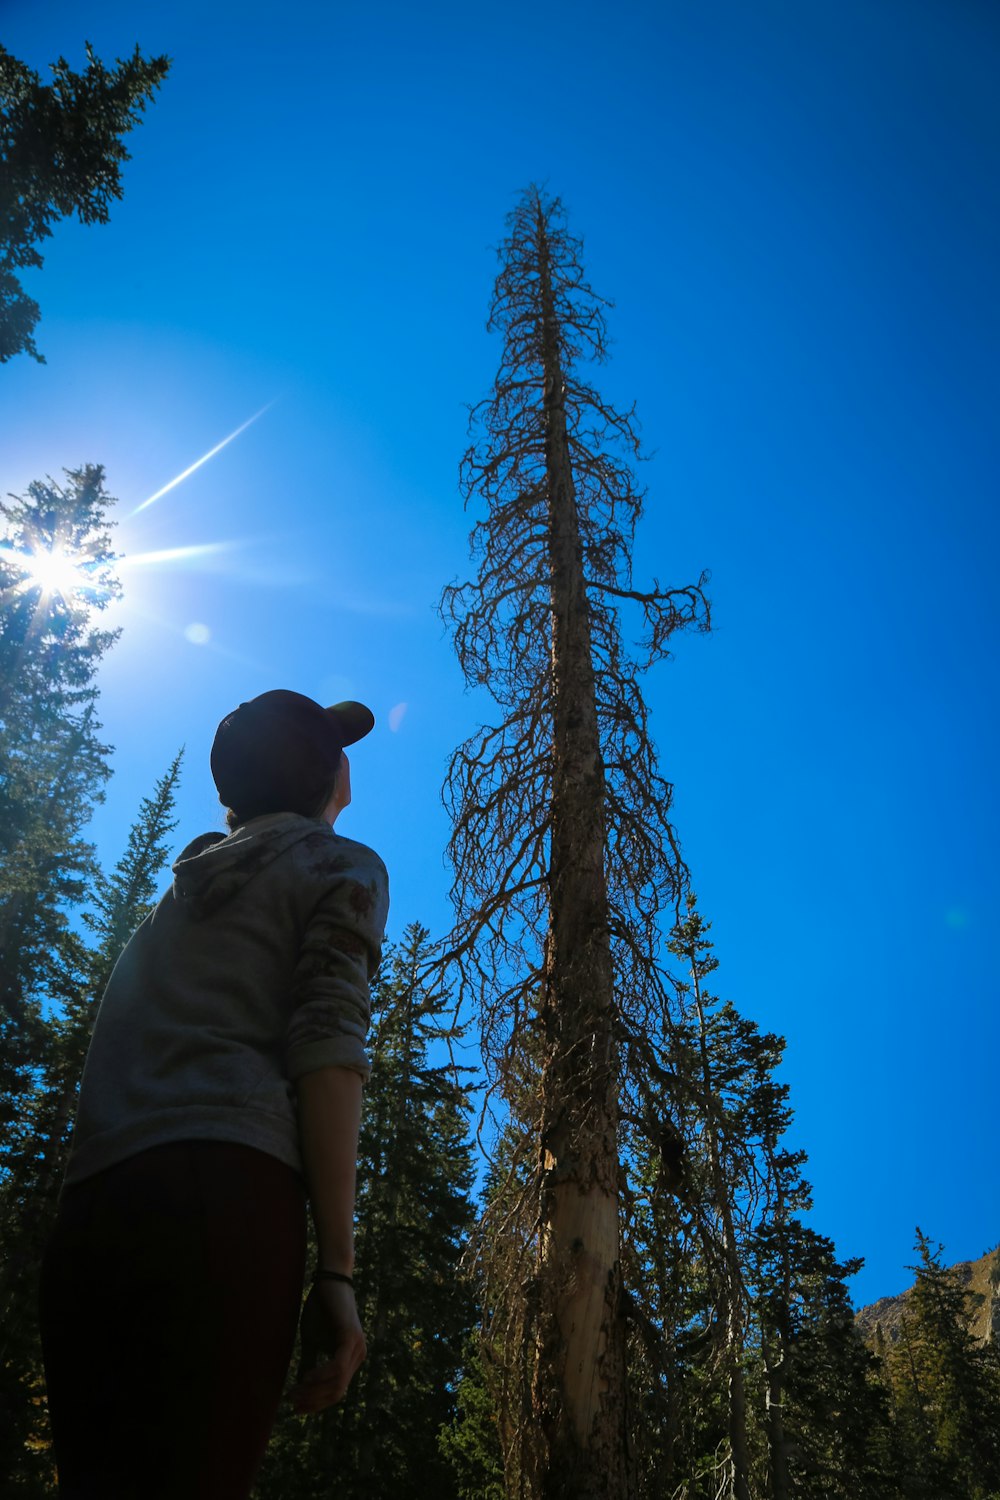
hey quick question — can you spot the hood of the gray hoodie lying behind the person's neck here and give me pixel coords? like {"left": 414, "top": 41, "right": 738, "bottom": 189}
{"left": 172, "top": 813, "right": 322, "bottom": 920}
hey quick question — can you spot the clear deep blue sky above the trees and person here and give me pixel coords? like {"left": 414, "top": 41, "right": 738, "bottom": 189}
{"left": 0, "top": 0, "right": 1000, "bottom": 1302}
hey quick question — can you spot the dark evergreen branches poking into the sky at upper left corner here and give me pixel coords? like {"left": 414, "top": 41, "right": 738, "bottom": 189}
{"left": 0, "top": 44, "right": 169, "bottom": 363}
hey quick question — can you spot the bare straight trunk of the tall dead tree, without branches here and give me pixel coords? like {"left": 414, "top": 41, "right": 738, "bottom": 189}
{"left": 534, "top": 199, "right": 627, "bottom": 1500}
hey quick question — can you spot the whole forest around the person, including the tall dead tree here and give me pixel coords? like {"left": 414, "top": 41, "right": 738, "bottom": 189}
{"left": 0, "top": 29, "right": 1000, "bottom": 1500}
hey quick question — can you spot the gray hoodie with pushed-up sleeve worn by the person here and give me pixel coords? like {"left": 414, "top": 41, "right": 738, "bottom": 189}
{"left": 66, "top": 813, "right": 388, "bottom": 1184}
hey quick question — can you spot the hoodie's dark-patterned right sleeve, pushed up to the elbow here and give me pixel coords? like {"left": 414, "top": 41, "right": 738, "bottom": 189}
{"left": 286, "top": 857, "right": 388, "bottom": 1083}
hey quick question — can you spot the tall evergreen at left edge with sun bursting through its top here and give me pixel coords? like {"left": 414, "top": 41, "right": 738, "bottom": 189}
{"left": 0, "top": 467, "right": 118, "bottom": 1218}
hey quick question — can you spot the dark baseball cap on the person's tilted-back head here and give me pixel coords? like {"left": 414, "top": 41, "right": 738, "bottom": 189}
{"left": 211, "top": 689, "right": 375, "bottom": 816}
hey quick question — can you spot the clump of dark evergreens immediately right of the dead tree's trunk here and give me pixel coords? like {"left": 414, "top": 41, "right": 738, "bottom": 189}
{"left": 624, "top": 897, "right": 897, "bottom": 1500}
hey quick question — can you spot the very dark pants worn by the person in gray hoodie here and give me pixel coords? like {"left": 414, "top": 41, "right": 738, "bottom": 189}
{"left": 40, "top": 1142, "right": 306, "bottom": 1500}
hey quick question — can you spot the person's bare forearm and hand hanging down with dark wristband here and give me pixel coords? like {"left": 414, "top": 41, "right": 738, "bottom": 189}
{"left": 295, "top": 1068, "right": 367, "bottom": 1412}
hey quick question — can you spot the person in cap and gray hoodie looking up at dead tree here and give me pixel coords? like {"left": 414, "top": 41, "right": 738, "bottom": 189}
{"left": 40, "top": 689, "right": 388, "bottom": 1500}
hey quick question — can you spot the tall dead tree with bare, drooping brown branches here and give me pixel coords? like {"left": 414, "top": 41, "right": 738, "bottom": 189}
{"left": 442, "top": 188, "right": 709, "bottom": 1500}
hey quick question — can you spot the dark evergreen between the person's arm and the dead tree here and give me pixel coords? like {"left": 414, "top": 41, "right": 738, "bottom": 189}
{"left": 256, "top": 924, "right": 475, "bottom": 1500}
